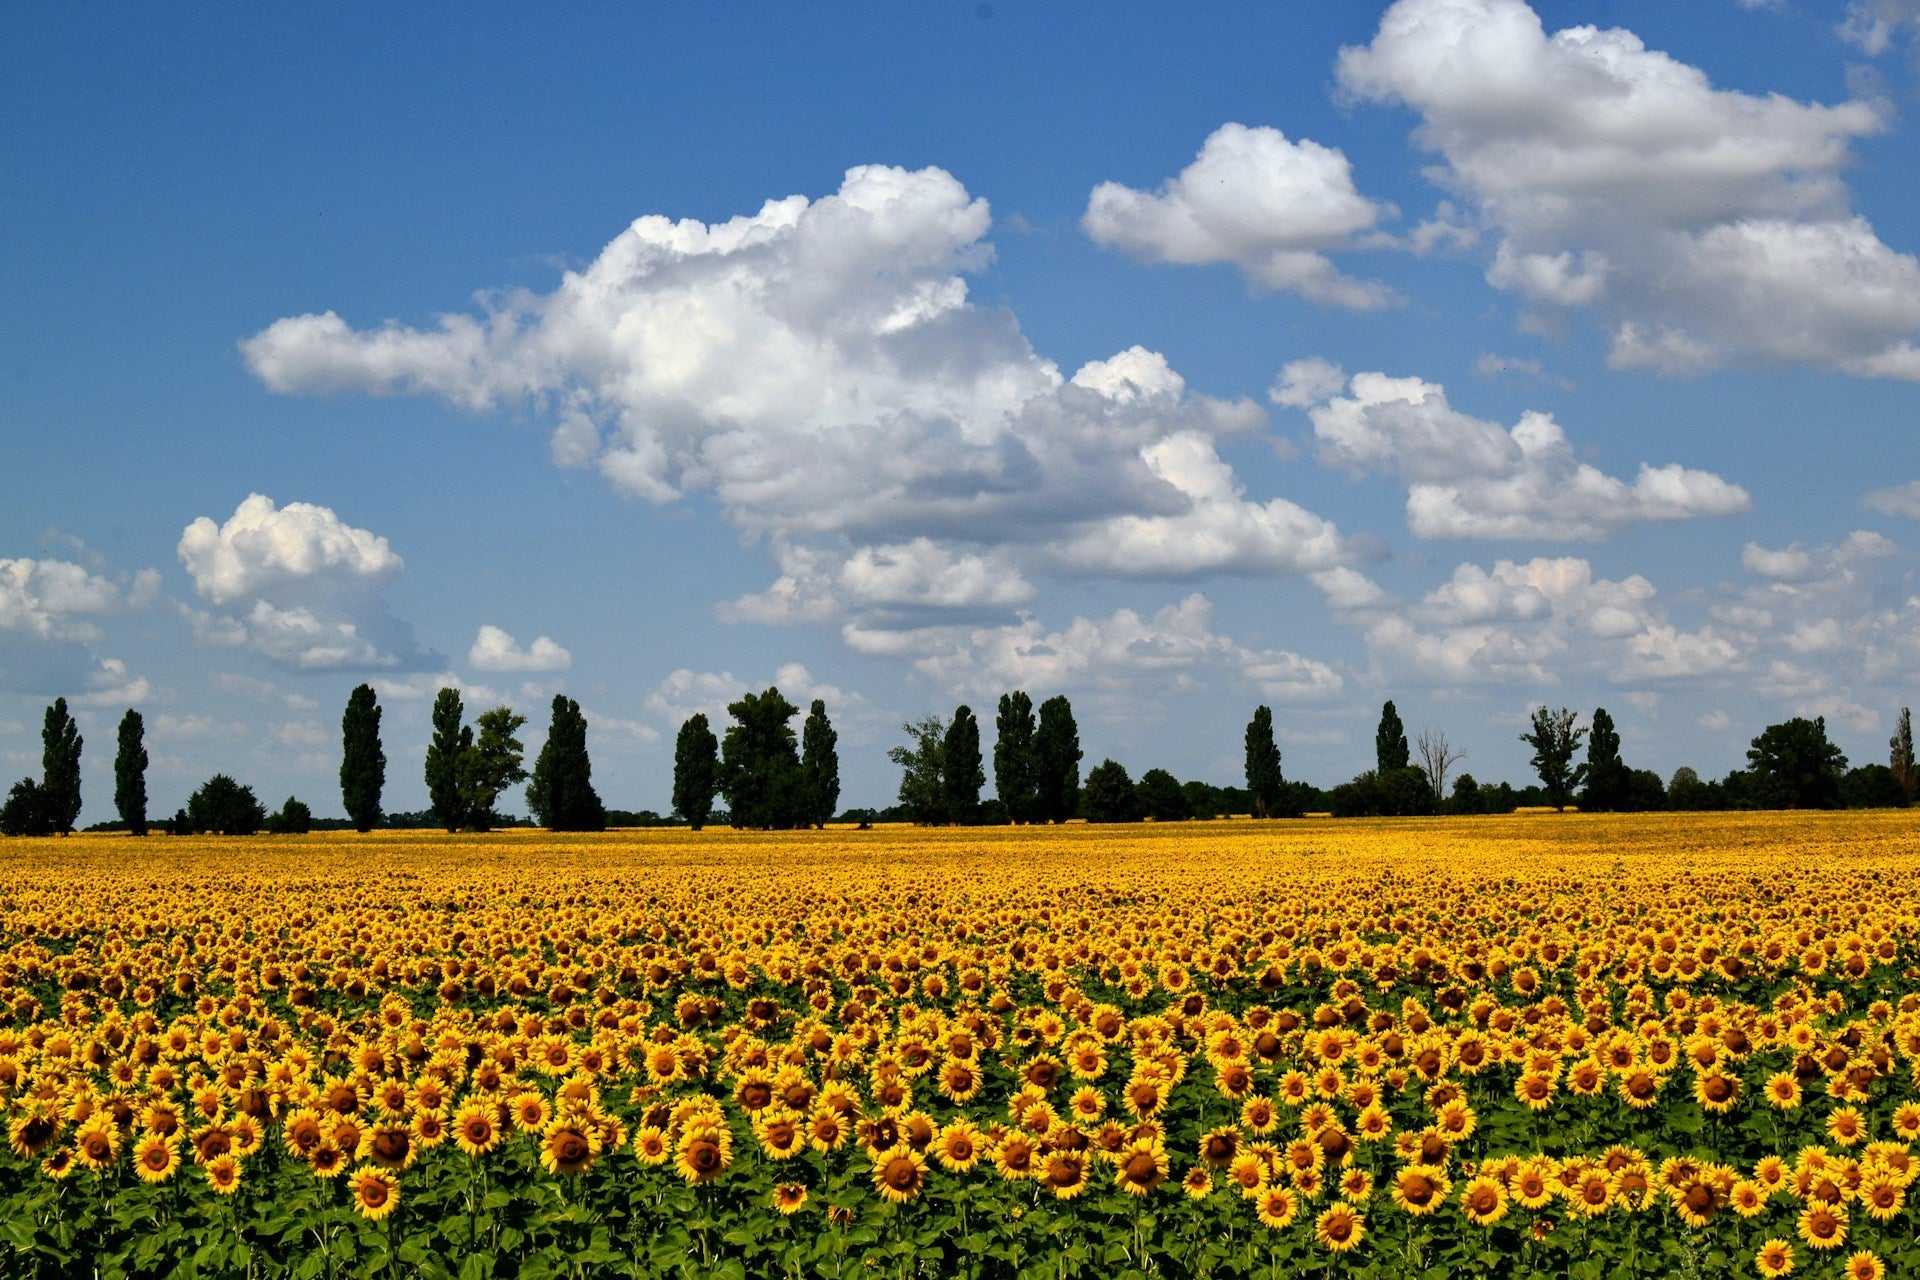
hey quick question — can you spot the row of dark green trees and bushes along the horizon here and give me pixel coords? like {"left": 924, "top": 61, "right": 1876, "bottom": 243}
{"left": 0, "top": 685, "right": 1920, "bottom": 835}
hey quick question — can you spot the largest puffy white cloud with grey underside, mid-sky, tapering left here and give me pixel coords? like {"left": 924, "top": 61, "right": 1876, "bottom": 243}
{"left": 242, "top": 165, "right": 1352, "bottom": 640}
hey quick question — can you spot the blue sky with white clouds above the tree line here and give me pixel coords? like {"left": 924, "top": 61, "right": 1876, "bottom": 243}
{"left": 0, "top": 0, "right": 1920, "bottom": 821}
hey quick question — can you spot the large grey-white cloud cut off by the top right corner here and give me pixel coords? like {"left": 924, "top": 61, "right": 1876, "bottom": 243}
{"left": 1338, "top": 0, "right": 1920, "bottom": 380}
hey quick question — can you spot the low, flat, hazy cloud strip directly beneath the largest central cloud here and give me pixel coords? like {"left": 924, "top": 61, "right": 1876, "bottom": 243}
{"left": 843, "top": 593, "right": 1344, "bottom": 700}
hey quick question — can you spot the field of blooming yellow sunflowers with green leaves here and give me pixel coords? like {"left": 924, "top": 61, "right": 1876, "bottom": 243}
{"left": 0, "top": 812, "right": 1920, "bottom": 1280}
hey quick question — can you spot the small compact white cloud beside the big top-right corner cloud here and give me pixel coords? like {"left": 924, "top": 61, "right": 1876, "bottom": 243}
{"left": 1081, "top": 125, "right": 1394, "bottom": 307}
